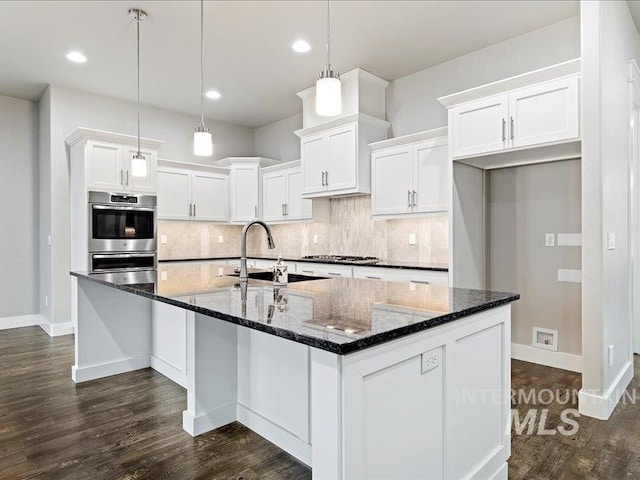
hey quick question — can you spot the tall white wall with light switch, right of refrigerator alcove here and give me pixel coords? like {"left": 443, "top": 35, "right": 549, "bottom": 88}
{"left": 580, "top": 1, "right": 640, "bottom": 413}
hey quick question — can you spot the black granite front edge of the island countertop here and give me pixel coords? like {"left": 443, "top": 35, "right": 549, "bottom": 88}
{"left": 70, "top": 272, "right": 520, "bottom": 355}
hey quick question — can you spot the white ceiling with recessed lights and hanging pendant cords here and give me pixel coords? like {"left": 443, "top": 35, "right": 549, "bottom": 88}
{"left": 0, "top": 0, "right": 579, "bottom": 127}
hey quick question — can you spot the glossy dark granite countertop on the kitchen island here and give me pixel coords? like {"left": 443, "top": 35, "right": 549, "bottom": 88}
{"left": 71, "top": 262, "right": 520, "bottom": 355}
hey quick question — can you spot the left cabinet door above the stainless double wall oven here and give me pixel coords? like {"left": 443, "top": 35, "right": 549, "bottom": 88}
{"left": 87, "top": 141, "right": 124, "bottom": 192}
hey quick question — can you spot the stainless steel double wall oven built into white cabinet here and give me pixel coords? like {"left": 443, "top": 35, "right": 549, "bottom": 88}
{"left": 88, "top": 192, "right": 158, "bottom": 273}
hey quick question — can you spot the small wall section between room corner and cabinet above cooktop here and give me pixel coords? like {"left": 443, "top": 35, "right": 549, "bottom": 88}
{"left": 253, "top": 113, "right": 302, "bottom": 162}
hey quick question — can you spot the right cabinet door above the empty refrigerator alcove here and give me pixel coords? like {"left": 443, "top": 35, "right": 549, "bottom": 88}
{"left": 509, "top": 77, "right": 580, "bottom": 148}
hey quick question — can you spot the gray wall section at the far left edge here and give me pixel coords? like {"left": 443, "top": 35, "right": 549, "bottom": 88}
{"left": 0, "top": 96, "right": 39, "bottom": 318}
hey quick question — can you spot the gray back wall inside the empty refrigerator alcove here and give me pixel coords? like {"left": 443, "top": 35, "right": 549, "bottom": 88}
{"left": 487, "top": 160, "right": 582, "bottom": 355}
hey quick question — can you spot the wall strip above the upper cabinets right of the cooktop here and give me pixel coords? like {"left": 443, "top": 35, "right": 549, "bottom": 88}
{"left": 386, "top": 17, "right": 580, "bottom": 137}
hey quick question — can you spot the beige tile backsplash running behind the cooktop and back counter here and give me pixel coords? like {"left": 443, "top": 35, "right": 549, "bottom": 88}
{"left": 158, "top": 196, "right": 449, "bottom": 263}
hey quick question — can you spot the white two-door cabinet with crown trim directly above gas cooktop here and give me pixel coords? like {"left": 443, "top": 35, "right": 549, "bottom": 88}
{"left": 295, "top": 114, "right": 390, "bottom": 198}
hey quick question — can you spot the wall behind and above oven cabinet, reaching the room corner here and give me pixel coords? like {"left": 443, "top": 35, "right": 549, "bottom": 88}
{"left": 41, "top": 85, "right": 253, "bottom": 323}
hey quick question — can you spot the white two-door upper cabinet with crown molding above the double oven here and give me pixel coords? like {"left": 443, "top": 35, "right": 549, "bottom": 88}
{"left": 66, "top": 128, "right": 163, "bottom": 193}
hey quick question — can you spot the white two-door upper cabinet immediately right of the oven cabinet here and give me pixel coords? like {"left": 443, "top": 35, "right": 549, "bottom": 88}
{"left": 158, "top": 160, "right": 229, "bottom": 222}
